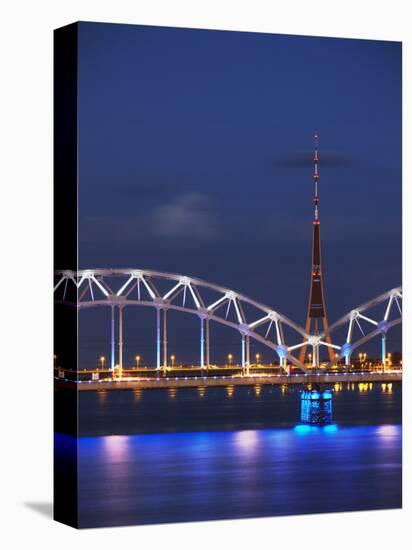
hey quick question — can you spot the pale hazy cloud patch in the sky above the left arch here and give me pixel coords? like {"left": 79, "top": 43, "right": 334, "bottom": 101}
{"left": 152, "top": 193, "right": 218, "bottom": 240}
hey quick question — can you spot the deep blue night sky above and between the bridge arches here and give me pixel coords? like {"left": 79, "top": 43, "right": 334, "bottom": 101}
{"left": 78, "top": 23, "right": 402, "bottom": 362}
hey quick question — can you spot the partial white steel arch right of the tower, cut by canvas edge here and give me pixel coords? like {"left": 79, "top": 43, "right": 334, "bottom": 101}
{"left": 319, "top": 287, "right": 402, "bottom": 367}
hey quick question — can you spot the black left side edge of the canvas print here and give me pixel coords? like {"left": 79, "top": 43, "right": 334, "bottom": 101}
{"left": 53, "top": 23, "right": 78, "bottom": 527}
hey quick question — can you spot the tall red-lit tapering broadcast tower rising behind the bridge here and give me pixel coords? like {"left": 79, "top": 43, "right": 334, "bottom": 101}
{"left": 299, "top": 133, "right": 334, "bottom": 365}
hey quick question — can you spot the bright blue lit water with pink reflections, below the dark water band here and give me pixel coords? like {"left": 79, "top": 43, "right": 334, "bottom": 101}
{"left": 78, "top": 425, "right": 402, "bottom": 527}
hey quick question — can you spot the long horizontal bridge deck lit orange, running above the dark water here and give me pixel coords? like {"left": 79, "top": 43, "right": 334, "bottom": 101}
{"left": 56, "top": 372, "right": 402, "bottom": 391}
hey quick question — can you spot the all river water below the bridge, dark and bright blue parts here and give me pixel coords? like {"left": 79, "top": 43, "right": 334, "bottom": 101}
{"left": 71, "top": 383, "right": 402, "bottom": 527}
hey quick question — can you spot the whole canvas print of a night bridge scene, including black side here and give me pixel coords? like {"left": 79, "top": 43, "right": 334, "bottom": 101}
{"left": 53, "top": 22, "right": 402, "bottom": 528}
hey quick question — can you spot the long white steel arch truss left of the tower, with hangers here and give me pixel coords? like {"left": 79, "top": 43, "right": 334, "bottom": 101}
{"left": 54, "top": 269, "right": 311, "bottom": 372}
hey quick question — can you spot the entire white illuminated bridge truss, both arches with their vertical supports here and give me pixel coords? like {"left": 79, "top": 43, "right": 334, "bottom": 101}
{"left": 54, "top": 269, "right": 402, "bottom": 372}
